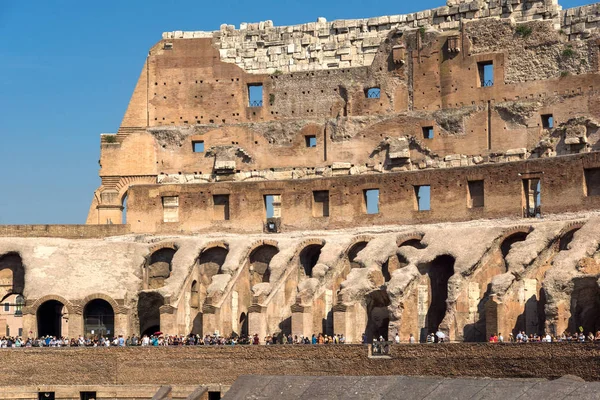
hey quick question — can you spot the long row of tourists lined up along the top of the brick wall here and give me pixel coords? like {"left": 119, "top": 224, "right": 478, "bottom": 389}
{"left": 0, "top": 328, "right": 600, "bottom": 348}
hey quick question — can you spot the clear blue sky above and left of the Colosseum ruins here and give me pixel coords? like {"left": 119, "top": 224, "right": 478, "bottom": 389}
{"left": 0, "top": 0, "right": 588, "bottom": 224}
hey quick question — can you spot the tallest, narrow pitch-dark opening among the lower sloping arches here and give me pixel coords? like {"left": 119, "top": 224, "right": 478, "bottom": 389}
{"left": 419, "top": 255, "right": 455, "bottom": 341}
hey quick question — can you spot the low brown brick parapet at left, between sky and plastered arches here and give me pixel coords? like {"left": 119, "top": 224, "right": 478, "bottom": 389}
{"left": 0, "top": 224, "right": 129, "bottom": 239}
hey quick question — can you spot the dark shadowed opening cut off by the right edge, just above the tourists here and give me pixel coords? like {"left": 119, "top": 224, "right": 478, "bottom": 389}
{"left": 558, "top": 276, "right": 600, "bottom": 335}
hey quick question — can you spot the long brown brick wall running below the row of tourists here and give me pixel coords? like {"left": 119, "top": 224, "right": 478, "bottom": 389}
{"left": 0, "top": 344, "right": 600, "bottom": 386}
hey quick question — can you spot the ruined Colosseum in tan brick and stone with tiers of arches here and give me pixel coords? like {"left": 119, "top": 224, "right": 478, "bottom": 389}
{"left": 0, "top": 0, "right": 600, "bottom": 396}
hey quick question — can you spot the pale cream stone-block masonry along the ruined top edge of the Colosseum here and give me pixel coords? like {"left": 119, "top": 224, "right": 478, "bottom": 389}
{"left": 163, "top": 0, "right": 576, "bottom": 73}
